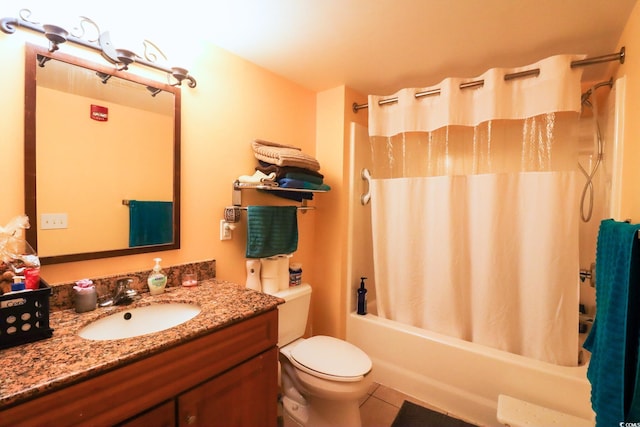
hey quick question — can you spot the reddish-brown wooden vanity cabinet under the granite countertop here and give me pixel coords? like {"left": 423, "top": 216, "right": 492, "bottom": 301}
{"left": 0, "top": 309, "right": 278, "bottom": 427}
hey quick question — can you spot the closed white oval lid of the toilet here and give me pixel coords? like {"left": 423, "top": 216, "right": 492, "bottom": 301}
{"left": 291, "top": 335, "right": 371, "bottom": 378}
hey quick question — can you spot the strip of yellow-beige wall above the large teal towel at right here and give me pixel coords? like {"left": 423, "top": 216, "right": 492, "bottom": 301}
{"left": 614, "top": 3, "right": 640, "bottom": 223}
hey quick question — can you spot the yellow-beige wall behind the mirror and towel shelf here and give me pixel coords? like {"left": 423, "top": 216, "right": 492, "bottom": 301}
{"left": 0, "top": 36, "right": 318, "bottom": 294}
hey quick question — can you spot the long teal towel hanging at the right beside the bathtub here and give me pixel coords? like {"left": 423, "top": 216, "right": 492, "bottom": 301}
{"left": 584, "top": 219, "right": 640, "bottom": 426}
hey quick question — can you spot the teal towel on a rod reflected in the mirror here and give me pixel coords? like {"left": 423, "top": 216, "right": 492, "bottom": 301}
{"left": 129, "top": 200, "right": 173, "bottom": 248}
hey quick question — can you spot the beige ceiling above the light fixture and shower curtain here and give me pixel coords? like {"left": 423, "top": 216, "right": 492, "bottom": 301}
{"left": 3, "top": 0, "right": 636, "bottom": 95}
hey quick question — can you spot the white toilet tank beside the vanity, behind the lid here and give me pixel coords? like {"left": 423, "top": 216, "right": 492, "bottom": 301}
{"left": 273, "top": 284, "right": 311, "bottom": 347}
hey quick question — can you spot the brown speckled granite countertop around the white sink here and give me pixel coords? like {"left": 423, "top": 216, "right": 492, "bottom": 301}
{"left": 0, "top": 279, "right": 284, "bottom": 410}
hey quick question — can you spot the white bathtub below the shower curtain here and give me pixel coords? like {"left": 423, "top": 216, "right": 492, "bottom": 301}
{"left": 347, "top": 313, "right": 595, "bottom": 426}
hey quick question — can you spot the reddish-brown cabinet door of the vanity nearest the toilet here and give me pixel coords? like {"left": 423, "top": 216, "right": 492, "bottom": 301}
{"left": 178, "top": 347, "right": 278, "bottom": 427}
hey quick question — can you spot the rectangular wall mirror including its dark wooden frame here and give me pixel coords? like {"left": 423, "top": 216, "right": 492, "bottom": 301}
{"left": 25, "top": 45, "right": 180, "bottom": 265}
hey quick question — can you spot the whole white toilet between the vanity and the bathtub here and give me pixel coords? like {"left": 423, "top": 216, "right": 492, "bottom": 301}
{"left": 273, "top": 284, "right": 372, "bottom": 427}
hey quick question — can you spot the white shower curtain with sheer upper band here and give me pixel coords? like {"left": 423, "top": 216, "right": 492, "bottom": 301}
{"left": 368, "top": 55, "right": 581, "bottom": 366}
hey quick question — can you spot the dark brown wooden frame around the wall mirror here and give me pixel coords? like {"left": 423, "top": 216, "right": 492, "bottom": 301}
{"left": 24, "top": 43, "right": 181, "bottom": 265}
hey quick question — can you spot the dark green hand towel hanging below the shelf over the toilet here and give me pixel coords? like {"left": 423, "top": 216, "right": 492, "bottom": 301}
{"left": 246, "top": 206, "right": 298, "bottom": 258}
